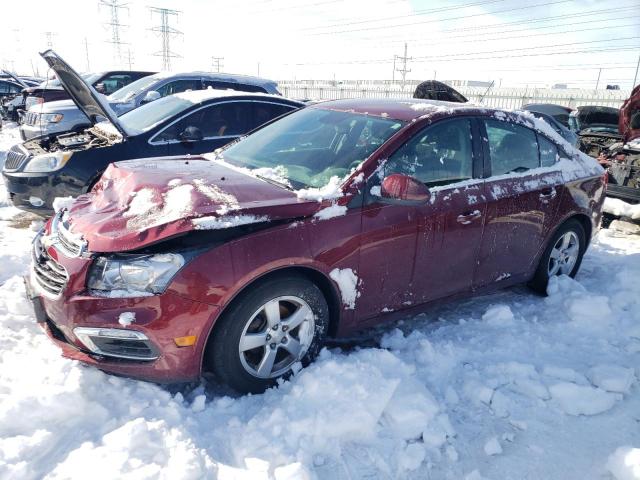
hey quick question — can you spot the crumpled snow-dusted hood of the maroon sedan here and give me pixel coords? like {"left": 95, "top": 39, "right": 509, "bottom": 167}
{"left": 65, "top": 157, "right": 322, "bottom": 252}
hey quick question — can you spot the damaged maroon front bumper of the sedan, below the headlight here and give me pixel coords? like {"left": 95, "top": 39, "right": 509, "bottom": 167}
{"left": 25, "top": 227, "right": 219, "bottom": 383}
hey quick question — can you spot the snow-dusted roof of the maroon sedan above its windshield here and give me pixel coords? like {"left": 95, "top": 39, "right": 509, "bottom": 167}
{"left": 309, "top": 98, "right": 490, "bottom": 122}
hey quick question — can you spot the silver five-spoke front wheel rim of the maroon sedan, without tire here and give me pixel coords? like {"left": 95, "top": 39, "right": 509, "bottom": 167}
{"left": 238, "top": 296, "right": 315, "bottom": 379}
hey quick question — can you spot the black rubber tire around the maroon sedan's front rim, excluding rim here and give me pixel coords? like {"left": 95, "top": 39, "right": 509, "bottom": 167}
{"left": 205, "top": 275, "right": 329, "bottom": 393}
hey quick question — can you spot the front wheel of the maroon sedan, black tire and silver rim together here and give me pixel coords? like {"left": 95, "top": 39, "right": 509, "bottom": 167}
{"left": 205, "top": 275, "right": 329, "bottom": 393}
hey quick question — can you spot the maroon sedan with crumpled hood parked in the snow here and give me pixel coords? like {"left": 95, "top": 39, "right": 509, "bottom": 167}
{"left": 27, "top": 99, "right": 605, "bottom": 392}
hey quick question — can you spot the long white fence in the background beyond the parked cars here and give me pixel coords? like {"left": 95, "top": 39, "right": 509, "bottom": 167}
{"left": 278, "top": 80, "right": 630, "bottom": 109}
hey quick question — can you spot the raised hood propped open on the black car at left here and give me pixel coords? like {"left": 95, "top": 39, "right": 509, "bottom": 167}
{"left": 40, "top": 50, "right": 127, "bottom": 138}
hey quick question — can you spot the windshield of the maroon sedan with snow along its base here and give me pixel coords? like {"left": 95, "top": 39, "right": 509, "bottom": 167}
{"left": 222, "top": 108, "right": 403, "bottom": 188}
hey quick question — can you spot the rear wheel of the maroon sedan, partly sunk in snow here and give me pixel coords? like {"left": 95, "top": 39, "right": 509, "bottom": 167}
{"left": 529, "top": 219, "right": 587, "bottom": 294}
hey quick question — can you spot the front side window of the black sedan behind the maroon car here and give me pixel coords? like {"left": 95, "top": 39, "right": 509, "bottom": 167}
{"left": 154, "top": 102, "right": 251, "bottom": 141}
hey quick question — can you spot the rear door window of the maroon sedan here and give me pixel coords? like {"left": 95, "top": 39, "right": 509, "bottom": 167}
{"left": 485, "top": 120, "right": 540, "bottom": 175}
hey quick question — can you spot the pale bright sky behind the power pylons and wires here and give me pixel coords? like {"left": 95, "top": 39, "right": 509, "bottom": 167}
{"left": 0, "top": 0, "right": 640, "bottom": 88}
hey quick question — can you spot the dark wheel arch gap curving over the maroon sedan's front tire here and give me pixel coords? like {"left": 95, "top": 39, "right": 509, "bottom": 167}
{"left": 200, "top": 265, "right": 342, "bottom": 372}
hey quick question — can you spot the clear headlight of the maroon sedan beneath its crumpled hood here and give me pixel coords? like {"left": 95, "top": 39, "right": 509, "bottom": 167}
{"left": 87, "top": 253, "right": 185, "bottom": 297}
